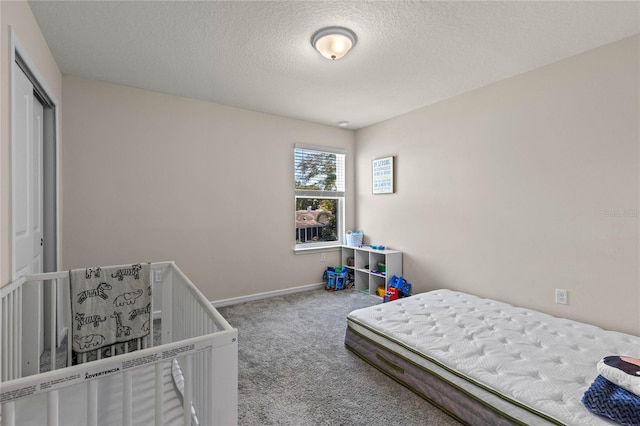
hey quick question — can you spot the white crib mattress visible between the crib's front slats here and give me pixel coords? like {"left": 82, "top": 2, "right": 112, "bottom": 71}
{"left": 11, "top": 361, "right": 184, "bottom": 426}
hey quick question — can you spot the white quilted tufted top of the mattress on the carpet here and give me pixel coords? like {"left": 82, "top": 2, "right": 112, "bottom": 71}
{"left": 348, "top": 290, "right": 640, "bottom": 425}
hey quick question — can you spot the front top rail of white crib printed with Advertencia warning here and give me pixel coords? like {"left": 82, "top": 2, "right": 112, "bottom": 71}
{"left": 0, "top": 340, "right": 212, "bottom": 404}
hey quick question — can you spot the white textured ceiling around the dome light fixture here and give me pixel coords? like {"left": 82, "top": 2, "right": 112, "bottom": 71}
{"left": 29, "top": 1, "right": 640, "bottom": 129}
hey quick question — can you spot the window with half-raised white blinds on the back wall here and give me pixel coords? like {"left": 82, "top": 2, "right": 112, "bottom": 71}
{"left": 294, "top": 145, "right": 345, "bottom": 249}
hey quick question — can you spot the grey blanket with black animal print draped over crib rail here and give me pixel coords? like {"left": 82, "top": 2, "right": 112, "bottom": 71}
{"left": 69, "top": 263, "right": 151, "bottom": 353}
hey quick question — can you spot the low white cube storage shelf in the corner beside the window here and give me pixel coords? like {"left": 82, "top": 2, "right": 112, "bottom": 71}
{"left": 342, "top": 246, "right": 402, "bottom": 295}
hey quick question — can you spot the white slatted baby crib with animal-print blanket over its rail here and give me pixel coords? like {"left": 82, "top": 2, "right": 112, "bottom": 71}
{"left": 0, "top": 262, "right": 238, "bottom": 426}
